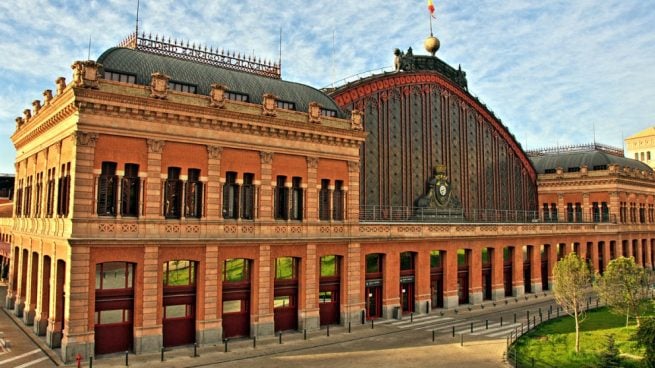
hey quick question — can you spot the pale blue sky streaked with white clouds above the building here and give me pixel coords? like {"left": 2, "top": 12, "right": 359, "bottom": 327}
{"left": 0, "top": 0, "right": 655, "bottom": 173}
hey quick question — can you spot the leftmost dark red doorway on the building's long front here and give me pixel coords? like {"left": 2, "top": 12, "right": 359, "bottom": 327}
{"left": 94, "top": 262, "right": 134, "bottom": 354}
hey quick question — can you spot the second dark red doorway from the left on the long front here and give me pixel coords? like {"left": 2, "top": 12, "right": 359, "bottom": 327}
{"left": 162, "top": 260, "right": 196, "bottom": 347}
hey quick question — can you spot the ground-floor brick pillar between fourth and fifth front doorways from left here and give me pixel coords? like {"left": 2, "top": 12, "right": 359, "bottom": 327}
{"left": 299, "top": 244, "right": 321, "bottom": 330}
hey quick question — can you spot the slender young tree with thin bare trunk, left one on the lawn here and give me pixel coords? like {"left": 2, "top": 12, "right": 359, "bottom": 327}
{"left": 553, "top": 253, "right": 591, "bottom": 353}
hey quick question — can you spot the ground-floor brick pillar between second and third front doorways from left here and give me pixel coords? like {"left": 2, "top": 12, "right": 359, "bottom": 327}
{"left": 196, "top": 246, "right": 223, "bottom": 345}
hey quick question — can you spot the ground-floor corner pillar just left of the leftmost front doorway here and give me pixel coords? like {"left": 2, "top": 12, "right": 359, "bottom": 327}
{"left": 61, "top": 245, "right": 95, "bottom": 362}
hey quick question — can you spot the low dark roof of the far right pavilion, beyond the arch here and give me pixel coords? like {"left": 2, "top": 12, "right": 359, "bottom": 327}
{"left": 530, "top": 150, "right": 653, "bottom": 174}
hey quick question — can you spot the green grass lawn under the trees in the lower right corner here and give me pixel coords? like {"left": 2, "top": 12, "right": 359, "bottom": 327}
{"left": 515, "top": 303, "right": 655, "bottom": 368}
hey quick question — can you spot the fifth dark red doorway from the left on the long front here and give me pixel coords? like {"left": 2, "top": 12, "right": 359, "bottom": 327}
{"left": 318, "top": 255, "right": 341, "bottom": 326}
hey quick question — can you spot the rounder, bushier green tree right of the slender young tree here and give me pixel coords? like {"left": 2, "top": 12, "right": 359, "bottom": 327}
{"left": 595, "top": 257, "right": 648, "bottom": 327}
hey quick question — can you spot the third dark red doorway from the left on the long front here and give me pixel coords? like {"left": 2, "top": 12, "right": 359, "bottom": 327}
{"left": 223, "top": 258, "right": 252, "bottom": 338}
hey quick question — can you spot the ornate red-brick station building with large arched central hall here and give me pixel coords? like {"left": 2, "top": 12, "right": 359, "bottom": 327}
{"left": 0, "top": 29, "right": 655, "bottom": 362}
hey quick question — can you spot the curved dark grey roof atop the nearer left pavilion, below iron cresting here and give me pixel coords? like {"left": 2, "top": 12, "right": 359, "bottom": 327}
{"left": 98, "top": 47, "right": 346, "bottom": 118}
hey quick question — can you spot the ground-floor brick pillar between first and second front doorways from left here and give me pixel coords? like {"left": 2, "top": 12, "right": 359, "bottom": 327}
{"left": 134, "top": 245, "right": 163, "bottom": 354}
